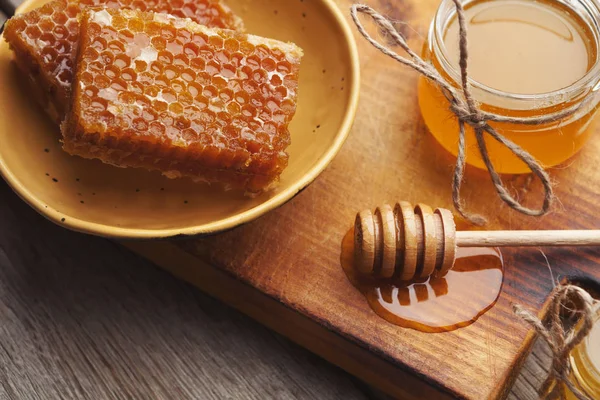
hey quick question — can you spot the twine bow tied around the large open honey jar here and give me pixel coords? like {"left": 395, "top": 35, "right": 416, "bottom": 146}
{"left": 350, "top": 0, "right": 587, "bottom": 225}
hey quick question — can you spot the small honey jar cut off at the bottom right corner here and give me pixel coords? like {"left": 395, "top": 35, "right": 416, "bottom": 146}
{"left": 567, "top": 303, "right": 600, "bottom": 400}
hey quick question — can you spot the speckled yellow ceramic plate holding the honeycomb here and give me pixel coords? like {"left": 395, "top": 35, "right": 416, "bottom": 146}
{"left": 0, "top": 0, "right": 359, "bottom": 238}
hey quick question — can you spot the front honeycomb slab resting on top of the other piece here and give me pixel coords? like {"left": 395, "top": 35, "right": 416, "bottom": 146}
{"left": 62, "top": 9, "right": 302, "bottom": 192}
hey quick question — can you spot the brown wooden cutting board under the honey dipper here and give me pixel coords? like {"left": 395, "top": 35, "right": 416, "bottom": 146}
{"left": 126, "top": 0, "right": 600, "bottom": 399}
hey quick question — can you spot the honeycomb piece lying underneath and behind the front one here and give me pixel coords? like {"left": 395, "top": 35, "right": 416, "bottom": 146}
{"left": 4, "top": 0, "right": 243, "bottom": 122}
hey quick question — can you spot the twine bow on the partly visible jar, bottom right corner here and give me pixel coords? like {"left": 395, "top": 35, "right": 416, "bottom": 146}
{"left": 513, "top": 285, "right": 594, "bottom": 400}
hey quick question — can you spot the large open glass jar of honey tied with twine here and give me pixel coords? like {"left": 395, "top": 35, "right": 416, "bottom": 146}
{"left": 418, "top": 0, "right": 600, "bottom": 173}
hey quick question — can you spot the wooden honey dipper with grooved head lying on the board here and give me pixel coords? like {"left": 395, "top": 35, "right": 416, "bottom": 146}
{"left": 354, "top": 201, "right": 600, "bottom": 281}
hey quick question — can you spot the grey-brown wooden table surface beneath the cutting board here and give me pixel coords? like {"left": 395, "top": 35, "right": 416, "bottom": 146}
{"left": 0, "top": 4, "right": 549, "bottom": 400}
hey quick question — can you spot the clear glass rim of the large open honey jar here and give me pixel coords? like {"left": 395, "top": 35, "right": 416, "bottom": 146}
{"left": 430, "top": 0, "right": 600, "bottom": 104}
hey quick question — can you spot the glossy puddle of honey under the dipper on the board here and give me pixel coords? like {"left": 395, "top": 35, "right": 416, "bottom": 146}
{"left": 341, "top": 230, "right": 504, "bottom": 333}
